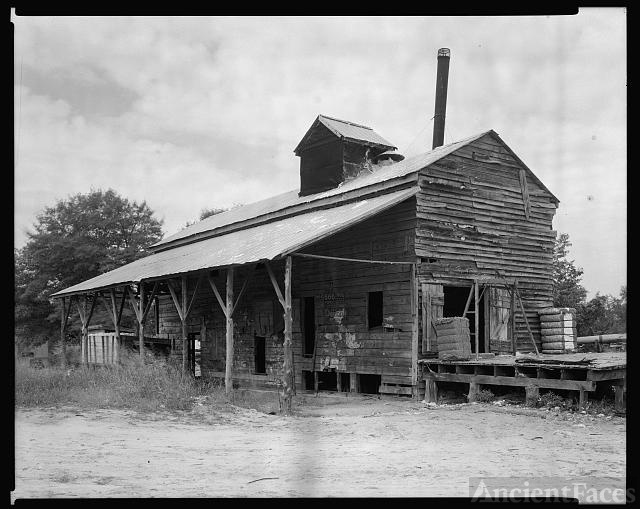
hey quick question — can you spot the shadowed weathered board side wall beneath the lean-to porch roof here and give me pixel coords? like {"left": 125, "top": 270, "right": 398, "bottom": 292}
{"left": 159, "top": 198, "right": 416, "bottom": 388}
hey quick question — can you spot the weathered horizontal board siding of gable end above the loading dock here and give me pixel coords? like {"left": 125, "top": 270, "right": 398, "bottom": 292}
{"left": 416, "top": 134, "right": 556, "bottom": 351}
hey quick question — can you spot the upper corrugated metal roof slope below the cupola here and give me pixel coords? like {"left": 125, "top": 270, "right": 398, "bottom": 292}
{"left": 153, "top": 131, "right": 491, "bottom": 247}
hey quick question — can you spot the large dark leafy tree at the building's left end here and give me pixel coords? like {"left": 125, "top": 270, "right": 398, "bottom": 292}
{"left": 15, "top": 189, "right": 162, "bottom": 344}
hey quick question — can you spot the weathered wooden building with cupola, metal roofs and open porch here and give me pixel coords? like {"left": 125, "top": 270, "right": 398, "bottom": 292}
{"left": 55, "top": 115, "right": 558, "bottom": 396}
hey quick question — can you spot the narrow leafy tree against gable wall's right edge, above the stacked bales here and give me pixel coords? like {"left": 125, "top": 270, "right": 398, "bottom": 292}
{"left": 553, "top": 233, "right": 587, "bottom": 308}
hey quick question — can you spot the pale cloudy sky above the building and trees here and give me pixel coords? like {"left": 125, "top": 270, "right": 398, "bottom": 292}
{"left": 12, "top": 7, "right": 627, "bottom": 297}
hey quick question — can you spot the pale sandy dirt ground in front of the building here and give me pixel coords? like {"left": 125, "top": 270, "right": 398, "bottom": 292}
{"left": 12, "top": 396, "right": 626, "bottom": 500}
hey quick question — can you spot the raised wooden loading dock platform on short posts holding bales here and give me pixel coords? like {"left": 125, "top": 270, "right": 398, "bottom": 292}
{"left": 418, "top": 352, "right": 627, "bottom": 411}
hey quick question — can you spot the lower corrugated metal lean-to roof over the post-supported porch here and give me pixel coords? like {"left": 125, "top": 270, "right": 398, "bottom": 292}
{"left": 53, "top": 187, "right": 418, "bottom": 296}
